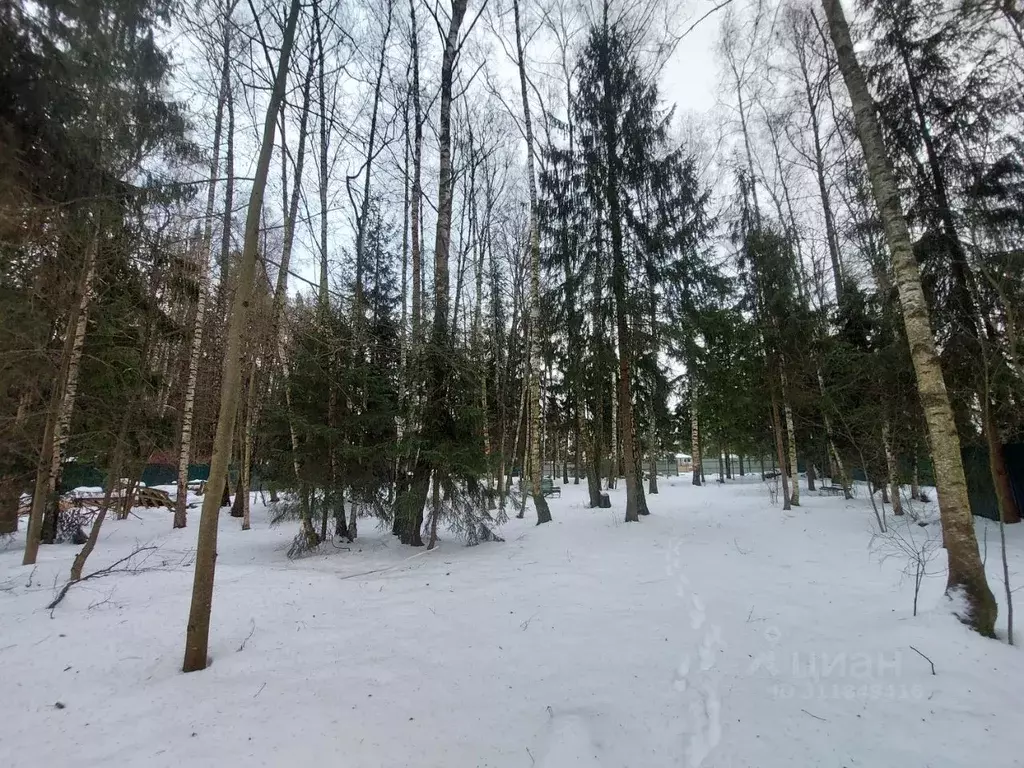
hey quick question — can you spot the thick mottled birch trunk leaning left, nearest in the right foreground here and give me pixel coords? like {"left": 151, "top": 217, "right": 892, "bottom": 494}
{"left": 822, "top": 0, "right": 998, "bottom": 637}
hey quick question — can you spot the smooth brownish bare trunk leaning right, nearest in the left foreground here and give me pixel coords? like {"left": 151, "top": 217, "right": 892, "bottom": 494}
{"left": 182, "top": 0, "right": 302, "bottom": 672}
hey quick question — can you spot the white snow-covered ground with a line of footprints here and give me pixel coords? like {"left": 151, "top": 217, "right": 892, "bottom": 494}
{"left": 0, "top": 477, "right": 1024, "bottom": 768}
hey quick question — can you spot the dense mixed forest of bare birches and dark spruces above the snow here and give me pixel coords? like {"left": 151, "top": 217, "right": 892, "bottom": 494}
{"left": 0, "top": 0, "right": 1024, "bottom": 667}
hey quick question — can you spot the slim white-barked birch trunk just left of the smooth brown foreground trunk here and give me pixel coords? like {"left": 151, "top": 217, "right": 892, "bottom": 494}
{"left": 173, "top": 10, "right": 236, "bottom": 528}
